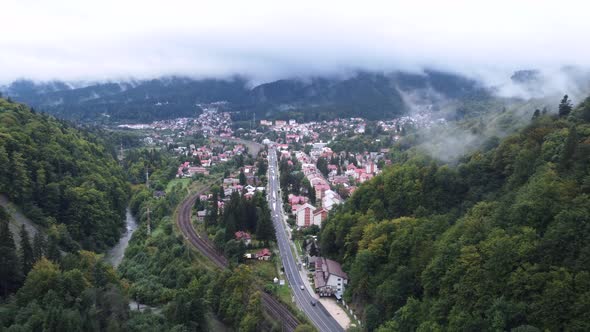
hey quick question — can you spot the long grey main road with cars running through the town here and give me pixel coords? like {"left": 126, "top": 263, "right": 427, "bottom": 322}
{"left": 268, "top": 148, "right": 344, "bottom": 332}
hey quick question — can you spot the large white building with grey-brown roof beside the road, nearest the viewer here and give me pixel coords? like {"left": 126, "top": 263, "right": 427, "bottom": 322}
{"left": 314, "top": 257, "right": 348, "bottom": 300}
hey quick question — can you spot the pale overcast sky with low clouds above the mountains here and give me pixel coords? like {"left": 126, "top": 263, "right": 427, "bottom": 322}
{"left": 0, "top": 0, "right": 590, "bottom": 82}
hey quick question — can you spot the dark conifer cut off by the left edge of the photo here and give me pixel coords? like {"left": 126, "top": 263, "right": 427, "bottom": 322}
{"left": 0, "top": 220, "right": 22, "bottom": 297}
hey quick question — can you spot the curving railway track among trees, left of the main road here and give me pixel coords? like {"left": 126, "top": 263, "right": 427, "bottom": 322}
{"left": 176, "top": 191, "right": 299, "bottom": 332}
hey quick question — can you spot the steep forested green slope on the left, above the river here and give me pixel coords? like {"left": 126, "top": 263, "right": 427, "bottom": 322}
{"left": 0, "top": 98, "right": 128, "bottom": 251}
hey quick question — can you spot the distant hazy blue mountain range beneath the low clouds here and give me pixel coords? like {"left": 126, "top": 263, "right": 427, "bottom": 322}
{"left": 1, "top": 70, "right": 489, "bottom": 123}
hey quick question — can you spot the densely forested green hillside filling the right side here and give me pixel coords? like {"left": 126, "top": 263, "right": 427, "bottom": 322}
{"left": 321, "top": 94, "right": 590, "bottom": 331}
